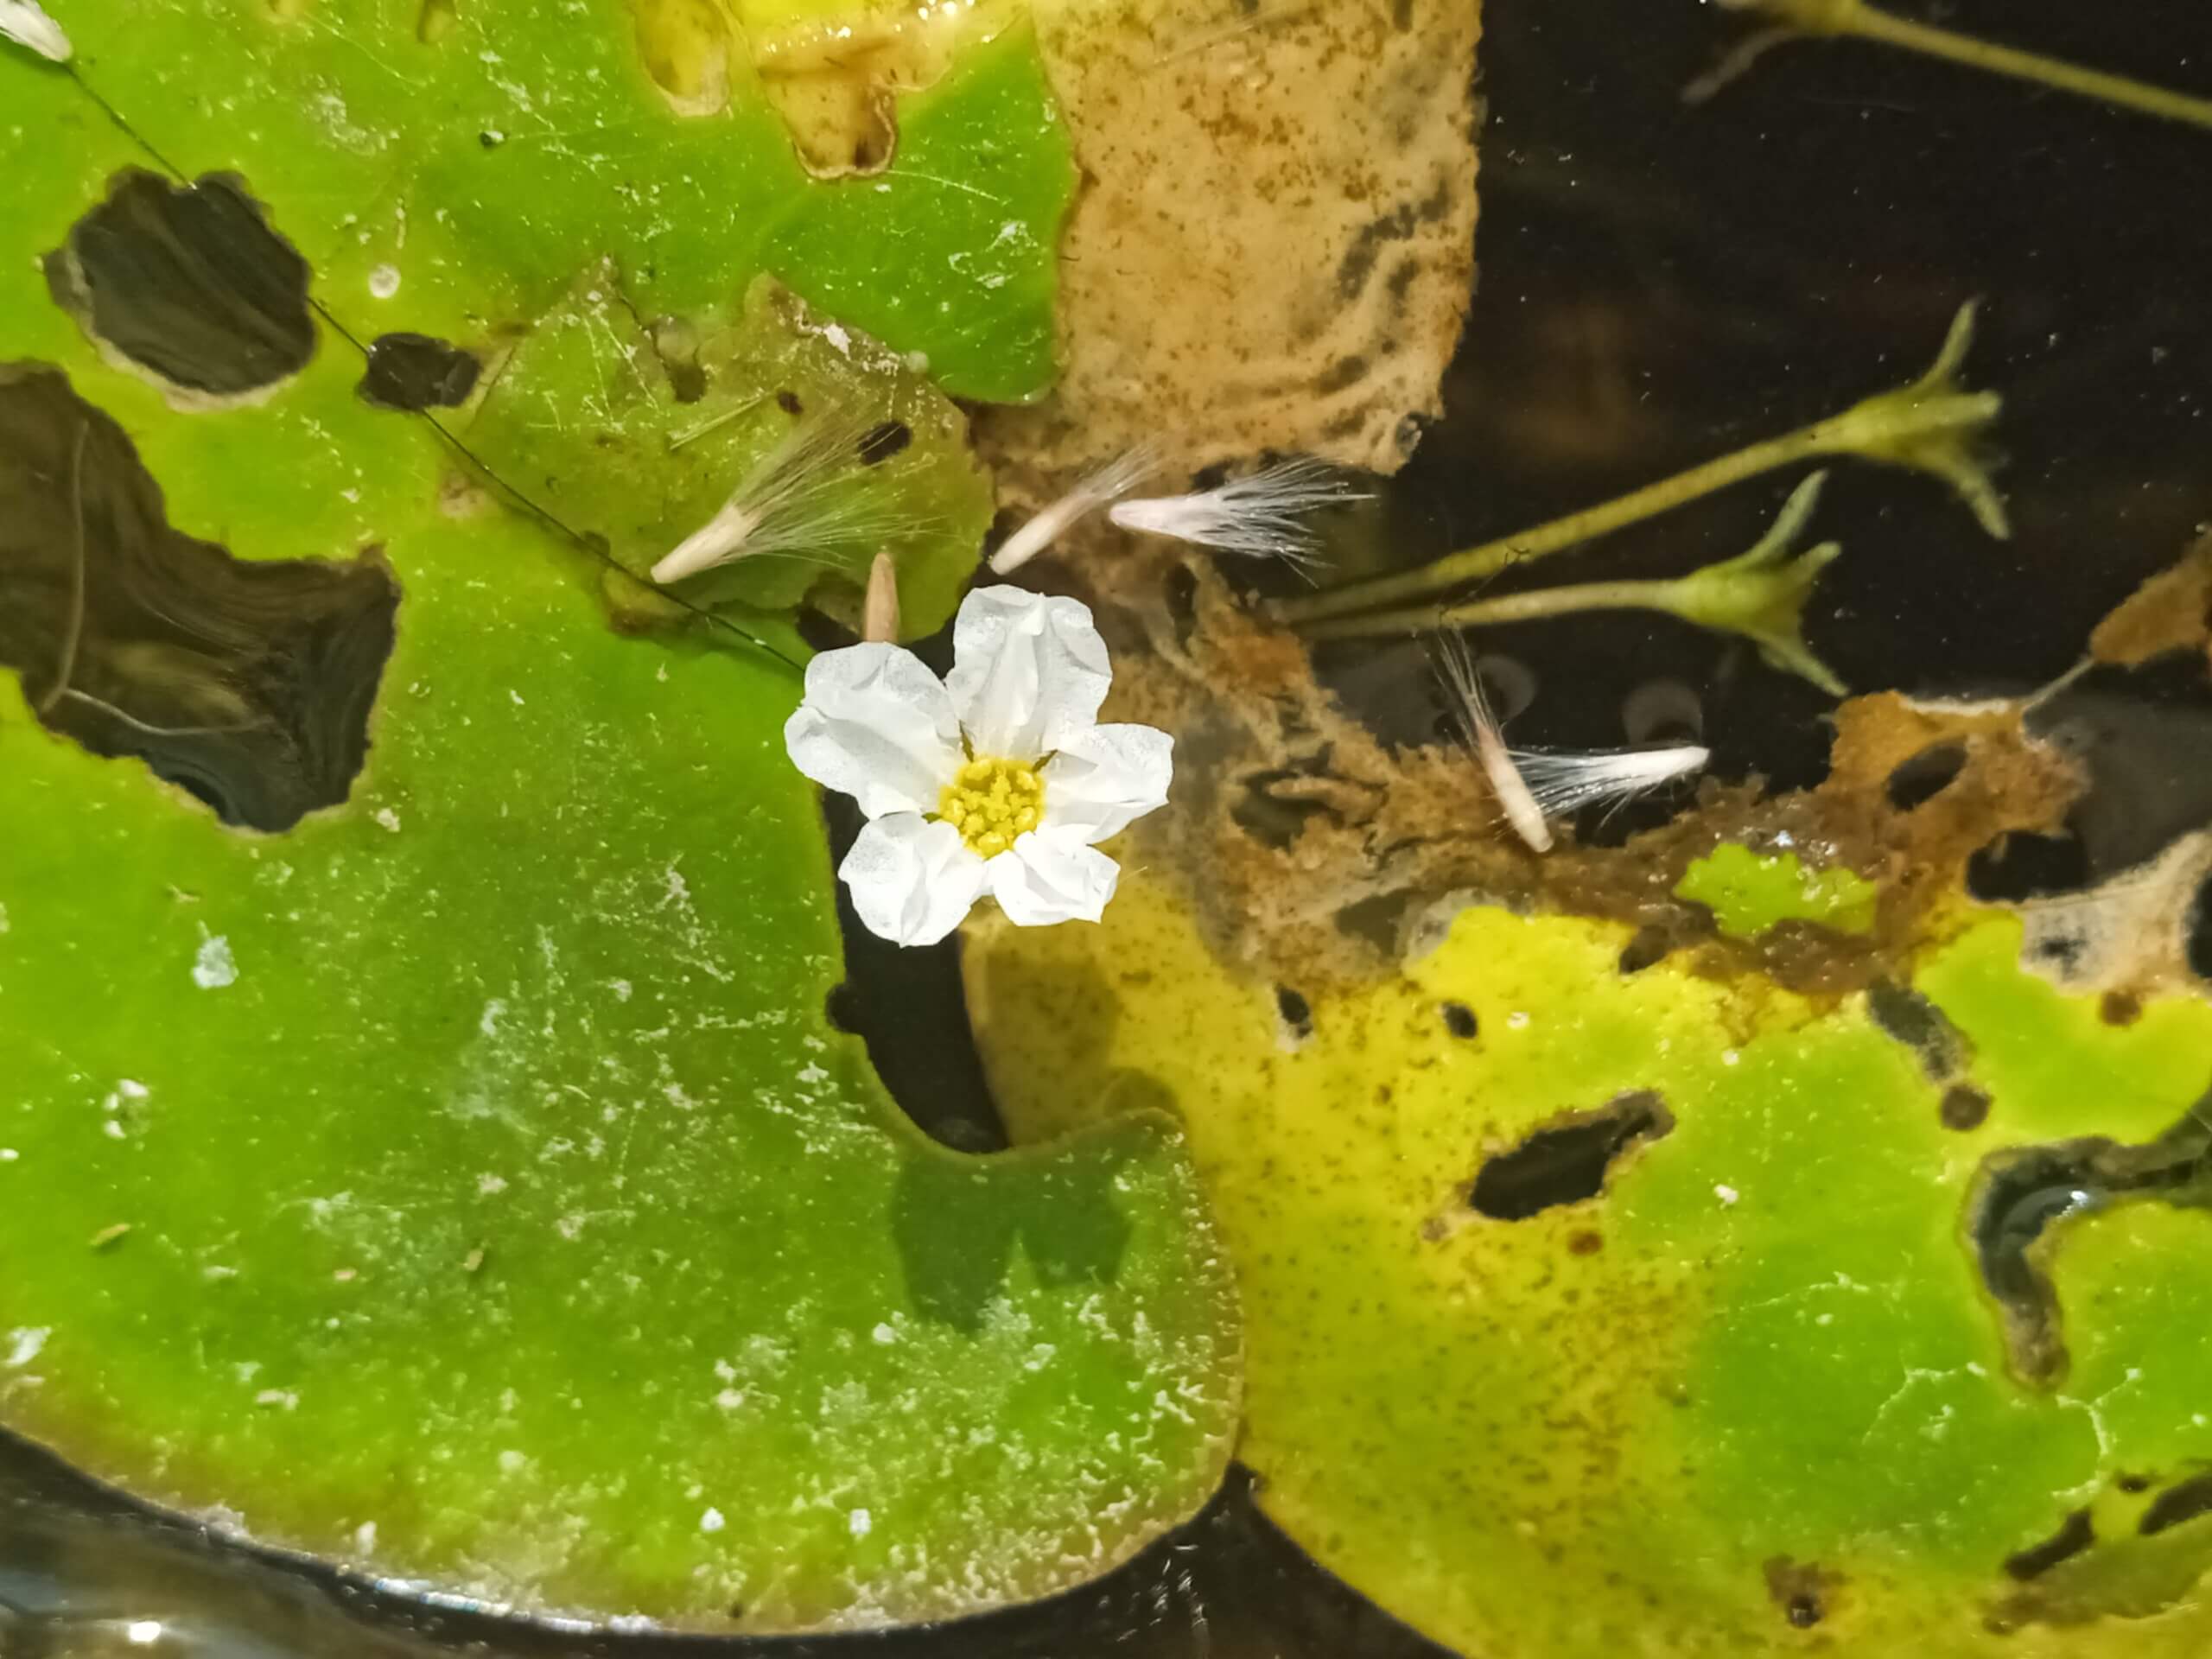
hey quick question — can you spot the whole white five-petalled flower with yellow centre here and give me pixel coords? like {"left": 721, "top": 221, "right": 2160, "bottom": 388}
{"left": 783, "top": 588, "right": 1174, "bottom": 944}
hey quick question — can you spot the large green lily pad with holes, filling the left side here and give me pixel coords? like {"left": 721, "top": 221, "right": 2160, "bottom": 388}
{"left": 0, "top": 0, "right": 1239, "bottom": 1630}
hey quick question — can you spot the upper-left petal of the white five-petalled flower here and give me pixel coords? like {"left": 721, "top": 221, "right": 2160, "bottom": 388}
{"left": 783, "top": 646, "right": 960, "bottom": 818}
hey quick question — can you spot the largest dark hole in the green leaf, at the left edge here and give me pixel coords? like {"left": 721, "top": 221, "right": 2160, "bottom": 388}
{"left": 0, "top": 363, "right": 400, "bottom": 832}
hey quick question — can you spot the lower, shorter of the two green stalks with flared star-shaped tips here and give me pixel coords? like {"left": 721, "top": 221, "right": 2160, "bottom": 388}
{"left": 1300, "top": 474, "right": 1842, "bottom": 696}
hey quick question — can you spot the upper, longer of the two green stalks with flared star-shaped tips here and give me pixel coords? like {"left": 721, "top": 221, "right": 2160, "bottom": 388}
{"left": 1281, "top": 301, "right": 2011, "bottom": 626}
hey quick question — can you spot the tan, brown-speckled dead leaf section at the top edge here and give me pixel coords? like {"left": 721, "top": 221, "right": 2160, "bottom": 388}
{"left": 980, "top": 0, "right": 1480, "bottom": 493}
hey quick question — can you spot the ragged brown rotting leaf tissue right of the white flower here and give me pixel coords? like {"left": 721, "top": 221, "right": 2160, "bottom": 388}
{"left": 1064, "top": 539, "right": 2082, "bottom": 998}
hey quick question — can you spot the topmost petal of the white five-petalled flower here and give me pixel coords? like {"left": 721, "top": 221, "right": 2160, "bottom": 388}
{"left": 944, "top": 588, "right": 1113, "bottom": 761}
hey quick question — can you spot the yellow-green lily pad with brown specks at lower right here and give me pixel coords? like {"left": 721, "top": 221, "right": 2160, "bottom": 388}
{"left": 967, "top": 876, "right": 2212, "bottom": 1659}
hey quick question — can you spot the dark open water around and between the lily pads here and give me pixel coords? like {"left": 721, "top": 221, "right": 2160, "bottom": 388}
{"left": 0, "top": 0, "right": 2212, "bottom": 1659}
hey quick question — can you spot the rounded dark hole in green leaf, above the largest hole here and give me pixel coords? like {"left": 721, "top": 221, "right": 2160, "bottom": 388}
{"left": 47, "top": 168, "right": 315, "bottom": 407}
